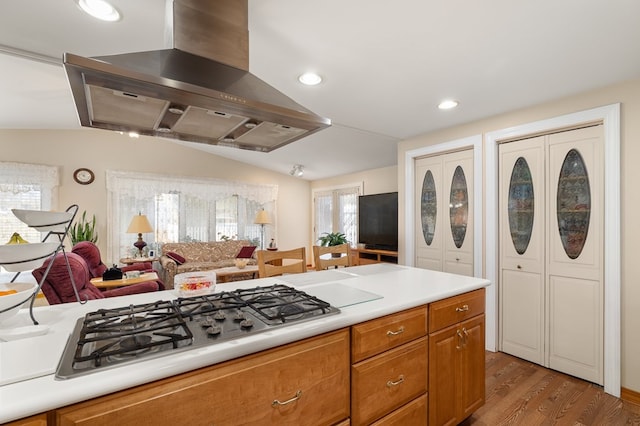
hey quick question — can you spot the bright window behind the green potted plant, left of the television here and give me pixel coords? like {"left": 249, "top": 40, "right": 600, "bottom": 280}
{"left": 313, "top": 184, "right": 362, "bottom": 246}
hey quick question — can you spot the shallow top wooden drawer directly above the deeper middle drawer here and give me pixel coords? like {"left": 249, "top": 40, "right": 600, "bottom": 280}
{"left": 351, "top": 306, "right": 427, "bottom": 362}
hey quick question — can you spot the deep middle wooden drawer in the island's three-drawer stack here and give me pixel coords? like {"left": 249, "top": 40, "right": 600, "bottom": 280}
{"left": 351, "top": 337, "right": 428, "bottom": 425}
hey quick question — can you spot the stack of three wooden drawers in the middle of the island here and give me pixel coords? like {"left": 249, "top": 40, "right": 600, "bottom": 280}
{"left": 351, "top": 306, "right": 428, "bottom": 425}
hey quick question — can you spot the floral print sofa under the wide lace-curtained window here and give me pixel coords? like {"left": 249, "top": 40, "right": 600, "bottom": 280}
{"left": 159, "top": 240, "right": 257, "bottom": 288}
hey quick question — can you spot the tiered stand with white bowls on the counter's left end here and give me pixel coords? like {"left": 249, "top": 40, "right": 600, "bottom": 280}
{"left": 0, "top": 204, "right": 81, "bottom": 325}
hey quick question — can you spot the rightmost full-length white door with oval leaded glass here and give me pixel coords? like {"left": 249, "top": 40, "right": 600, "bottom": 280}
{"left": 547, "top": 126, "right": 604, "bottom": 384}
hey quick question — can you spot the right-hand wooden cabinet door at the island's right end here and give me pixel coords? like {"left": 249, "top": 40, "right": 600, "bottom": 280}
{"left": 458, "top": 314, "right": 485, "bottom": 420}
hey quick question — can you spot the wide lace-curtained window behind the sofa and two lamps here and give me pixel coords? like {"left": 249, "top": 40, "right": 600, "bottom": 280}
{"left": 107, "top": 171, "right": 277, "bottom": 262}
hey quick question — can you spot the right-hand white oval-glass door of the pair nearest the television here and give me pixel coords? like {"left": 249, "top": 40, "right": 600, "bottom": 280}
{"left": 443, "top": 150, "right": 474, "bottom": 276}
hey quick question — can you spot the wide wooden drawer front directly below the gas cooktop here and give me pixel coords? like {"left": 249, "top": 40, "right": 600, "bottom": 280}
{"left": 56, "top": 329, "right": 349, "bottom": 425}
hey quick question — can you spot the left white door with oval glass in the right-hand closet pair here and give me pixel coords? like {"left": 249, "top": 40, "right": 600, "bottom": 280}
{"left": 499, "top": 136, "right": 546, "bottom": 364}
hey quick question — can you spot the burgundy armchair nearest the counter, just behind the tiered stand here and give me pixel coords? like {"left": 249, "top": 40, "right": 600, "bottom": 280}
{"left": 31, "top": 253, "right": 160, "bottom": 305}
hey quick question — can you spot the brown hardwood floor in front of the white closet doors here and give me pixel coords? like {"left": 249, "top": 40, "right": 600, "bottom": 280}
{"left": 461, "top": 352, "right": 640, "bottom": 426}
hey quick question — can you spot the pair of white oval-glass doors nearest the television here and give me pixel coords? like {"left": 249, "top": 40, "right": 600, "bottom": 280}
{"left": 414, "top": 150, "right": 474, "bottom": 276}
